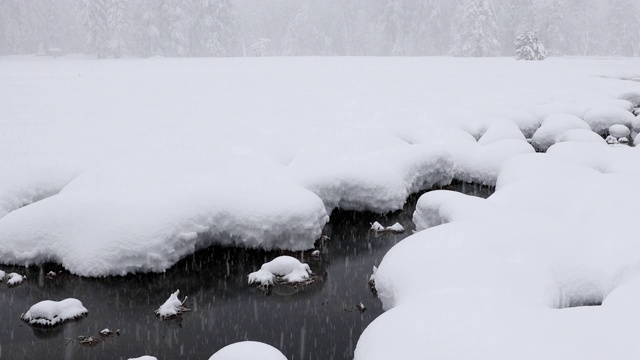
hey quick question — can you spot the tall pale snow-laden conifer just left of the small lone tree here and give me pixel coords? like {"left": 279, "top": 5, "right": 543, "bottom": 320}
{"left": 453, "top": 0, "right": 502, "bottom": 56}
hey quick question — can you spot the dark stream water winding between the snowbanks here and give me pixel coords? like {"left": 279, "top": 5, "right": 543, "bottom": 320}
{"left": 0, "top": 184, "right": 491, "bottom": 360}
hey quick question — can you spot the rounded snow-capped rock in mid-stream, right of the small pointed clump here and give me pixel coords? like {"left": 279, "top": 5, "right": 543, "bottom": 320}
{"left": 249, "top": 255, "right": 311, "bottom": 286}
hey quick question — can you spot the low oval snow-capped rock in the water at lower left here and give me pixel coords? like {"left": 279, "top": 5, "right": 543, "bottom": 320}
{"left": 20, "top": 298, "right": 89, "bottom": 326}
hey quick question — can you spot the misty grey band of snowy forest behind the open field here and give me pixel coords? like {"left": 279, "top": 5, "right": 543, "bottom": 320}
{"left": 0, "top": 0, "right": 640, "bottom": 58}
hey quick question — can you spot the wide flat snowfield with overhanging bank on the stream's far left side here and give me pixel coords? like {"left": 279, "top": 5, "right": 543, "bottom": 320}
{"left": 0, "top": 57, "right": 640, "bottom": 276}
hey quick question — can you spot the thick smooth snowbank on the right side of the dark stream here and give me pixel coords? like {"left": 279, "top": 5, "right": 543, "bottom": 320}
{"left": 355, "top": 141, "right": 640, "bottom": 360}
